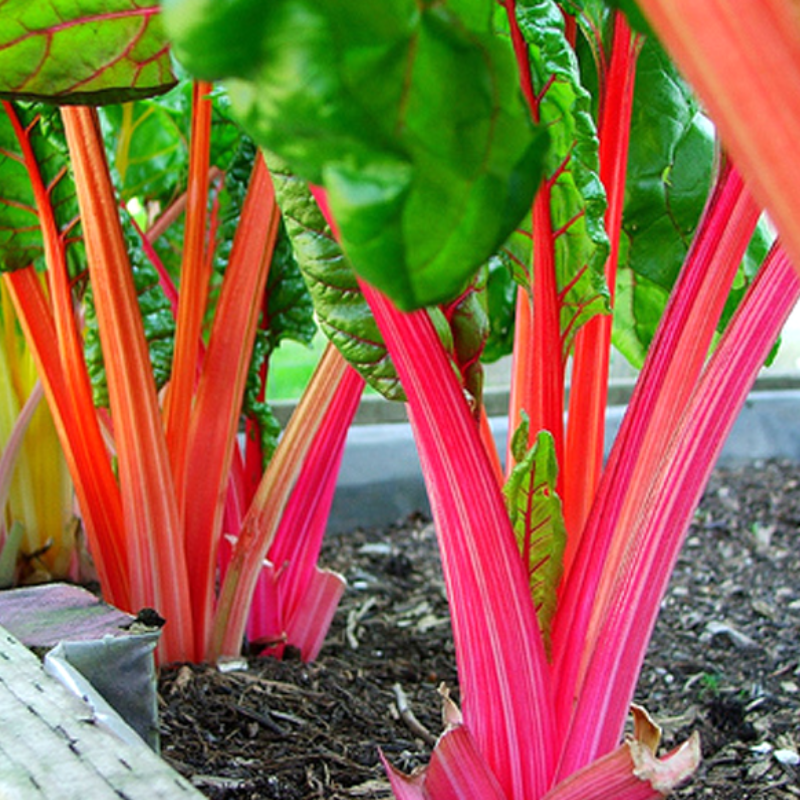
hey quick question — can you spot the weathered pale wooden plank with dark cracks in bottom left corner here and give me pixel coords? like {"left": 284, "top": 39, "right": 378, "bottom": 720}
{"left": 0, "top": 627, "right": 202, "bottom": 800}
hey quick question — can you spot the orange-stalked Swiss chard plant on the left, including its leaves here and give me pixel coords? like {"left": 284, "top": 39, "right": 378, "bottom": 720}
{"left": 0, "top": 0, "right": 380, "bottom": 661}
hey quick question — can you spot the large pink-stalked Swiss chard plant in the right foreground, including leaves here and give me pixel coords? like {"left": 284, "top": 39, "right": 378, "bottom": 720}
{"left": 164, "top": 0, "right": 800, "bottom": 800}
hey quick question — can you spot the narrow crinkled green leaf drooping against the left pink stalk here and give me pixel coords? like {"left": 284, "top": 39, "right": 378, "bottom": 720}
{"left": 267, "top": 156, "right": 404, "bottom": 400}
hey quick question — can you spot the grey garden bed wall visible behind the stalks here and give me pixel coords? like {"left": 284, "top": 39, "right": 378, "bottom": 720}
{"left": 329, "top": 390, "right": 800, "bottom": 533}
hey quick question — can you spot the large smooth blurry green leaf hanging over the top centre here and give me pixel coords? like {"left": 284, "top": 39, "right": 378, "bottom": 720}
{"left": 164, "top": 0, "right": 546, "bottom": 308}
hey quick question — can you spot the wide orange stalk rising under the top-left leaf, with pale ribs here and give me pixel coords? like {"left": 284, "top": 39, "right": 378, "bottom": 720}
{"left": 62, "top": 106, "right": 196, "bottom": 661}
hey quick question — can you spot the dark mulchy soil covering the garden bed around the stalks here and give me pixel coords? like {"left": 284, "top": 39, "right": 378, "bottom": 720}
{"left": 161, "top": 463, "right": 800, "bottom": 800}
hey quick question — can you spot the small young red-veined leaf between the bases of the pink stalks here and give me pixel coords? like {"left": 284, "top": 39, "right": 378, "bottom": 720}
{"left": 503, "top": 420, "right": 567, "bottom": 653}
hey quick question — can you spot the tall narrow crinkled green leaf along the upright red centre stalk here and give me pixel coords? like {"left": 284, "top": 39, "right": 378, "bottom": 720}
{"left": 517, "top": 0, "right": 608, "bottom": 354}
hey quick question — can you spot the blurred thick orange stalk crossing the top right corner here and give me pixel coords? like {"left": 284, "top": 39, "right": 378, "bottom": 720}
{"left": 639, "top": 0, "right": 800, "bottom": 278}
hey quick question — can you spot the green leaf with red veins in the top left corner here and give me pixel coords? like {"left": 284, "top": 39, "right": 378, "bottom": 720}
{"left": 0, "top": 0, "right": 175, "bottom": 105}
